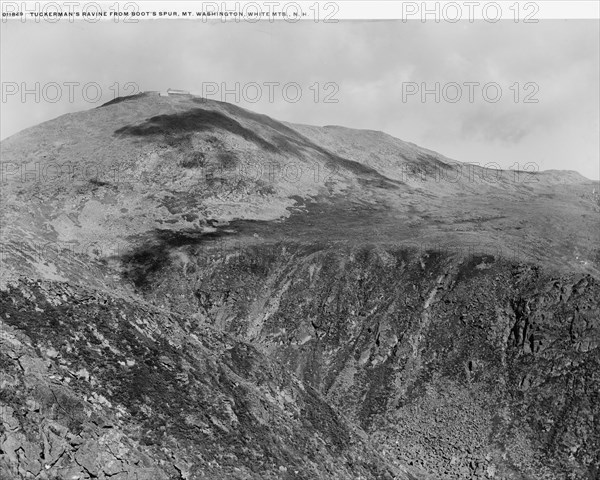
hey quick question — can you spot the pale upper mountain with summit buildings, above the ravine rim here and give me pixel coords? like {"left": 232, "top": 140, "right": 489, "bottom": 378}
{"left": 1, "top": 94, "right": 600, "bottom": 283}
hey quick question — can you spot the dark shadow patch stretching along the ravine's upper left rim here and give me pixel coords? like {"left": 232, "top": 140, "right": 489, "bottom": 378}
{"left": 119, "top": 195, "right": 419, "bottom": 290}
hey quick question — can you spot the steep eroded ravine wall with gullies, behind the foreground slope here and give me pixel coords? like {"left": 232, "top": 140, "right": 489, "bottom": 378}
{"left": 117, "top": 244, "right": 600, "bottom": 478}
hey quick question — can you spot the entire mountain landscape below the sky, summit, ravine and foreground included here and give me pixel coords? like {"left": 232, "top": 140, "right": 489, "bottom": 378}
{"left": 0, "top": 92, "right": 600, "bottom": 480}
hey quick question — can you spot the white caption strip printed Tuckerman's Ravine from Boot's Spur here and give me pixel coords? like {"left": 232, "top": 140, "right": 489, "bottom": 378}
{"left": 1, "top": 0, "right": 600, "bottom": 23}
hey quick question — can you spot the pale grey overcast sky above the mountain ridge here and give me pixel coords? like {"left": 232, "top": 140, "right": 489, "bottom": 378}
{"left": 0, "top": 20, "right": 600, "bottom": 179}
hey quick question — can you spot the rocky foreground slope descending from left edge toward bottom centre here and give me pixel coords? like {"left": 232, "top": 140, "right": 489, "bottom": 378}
{"left": 0, "top": 281, "right": 414, "bottom": 480}
